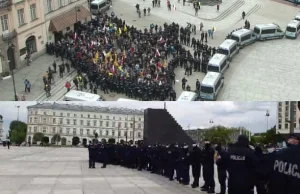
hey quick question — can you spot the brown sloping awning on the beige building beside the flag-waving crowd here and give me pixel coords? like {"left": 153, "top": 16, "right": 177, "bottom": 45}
{"left": 49, "top": 5, "right": 91, "bottom": 32}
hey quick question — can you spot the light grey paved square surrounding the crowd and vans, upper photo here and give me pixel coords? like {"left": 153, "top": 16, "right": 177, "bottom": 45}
{"left": 0, "top": 0, "right": 300, "bottom": 101}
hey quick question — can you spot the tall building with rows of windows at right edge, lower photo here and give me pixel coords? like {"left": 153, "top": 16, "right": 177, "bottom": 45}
{"left": 276, "top": 101, "right": 300, "bottom": 134}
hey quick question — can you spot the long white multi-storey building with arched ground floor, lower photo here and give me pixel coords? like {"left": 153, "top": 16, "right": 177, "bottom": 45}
{"left": 26, "top": 103, "right": 144, "bottom": 145}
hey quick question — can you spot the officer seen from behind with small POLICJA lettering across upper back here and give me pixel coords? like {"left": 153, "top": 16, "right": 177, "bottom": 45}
{"left": 222, "top": 135, "right": 258, "bottom": 194}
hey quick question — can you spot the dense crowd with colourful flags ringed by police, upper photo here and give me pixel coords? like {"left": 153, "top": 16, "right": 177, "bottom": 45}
{"left": 43, "top": 9, "right": 215, "bottom": 101}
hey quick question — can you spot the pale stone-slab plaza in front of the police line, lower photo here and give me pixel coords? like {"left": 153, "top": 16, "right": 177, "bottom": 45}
{"left": 0, "top": 147, "right": 227, "bottom": 194}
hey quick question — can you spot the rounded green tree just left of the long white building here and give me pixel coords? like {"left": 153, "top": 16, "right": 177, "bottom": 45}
{"left": 9, "top": 121, "right": 27, "bottom": 144}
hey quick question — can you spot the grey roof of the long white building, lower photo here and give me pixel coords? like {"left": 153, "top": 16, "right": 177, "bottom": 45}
{"left": 27, "top": 102, "right": 144, "bottom": 115}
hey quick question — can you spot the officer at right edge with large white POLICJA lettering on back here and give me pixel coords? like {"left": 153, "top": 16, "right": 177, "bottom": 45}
{"left": 267, "top": 134, "right": 300, "bottom": 194}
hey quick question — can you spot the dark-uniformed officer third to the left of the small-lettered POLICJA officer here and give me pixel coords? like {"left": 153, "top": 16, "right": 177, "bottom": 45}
{"left": 191, "top": 144, "right": 201, "bottom": 188}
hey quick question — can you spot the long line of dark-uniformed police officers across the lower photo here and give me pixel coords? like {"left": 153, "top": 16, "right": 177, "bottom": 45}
{"left": 88, "top": 134, "right": 300, "bottom": 194}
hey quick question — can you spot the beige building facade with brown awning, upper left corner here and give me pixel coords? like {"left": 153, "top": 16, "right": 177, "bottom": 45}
{"left": 0, "top": 0, "right": 90, "bottom": 75}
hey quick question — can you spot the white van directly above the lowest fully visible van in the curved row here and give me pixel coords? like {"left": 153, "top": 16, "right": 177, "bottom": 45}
{"left": 207, "top": 53, "right": 229, "bottom": 73}
